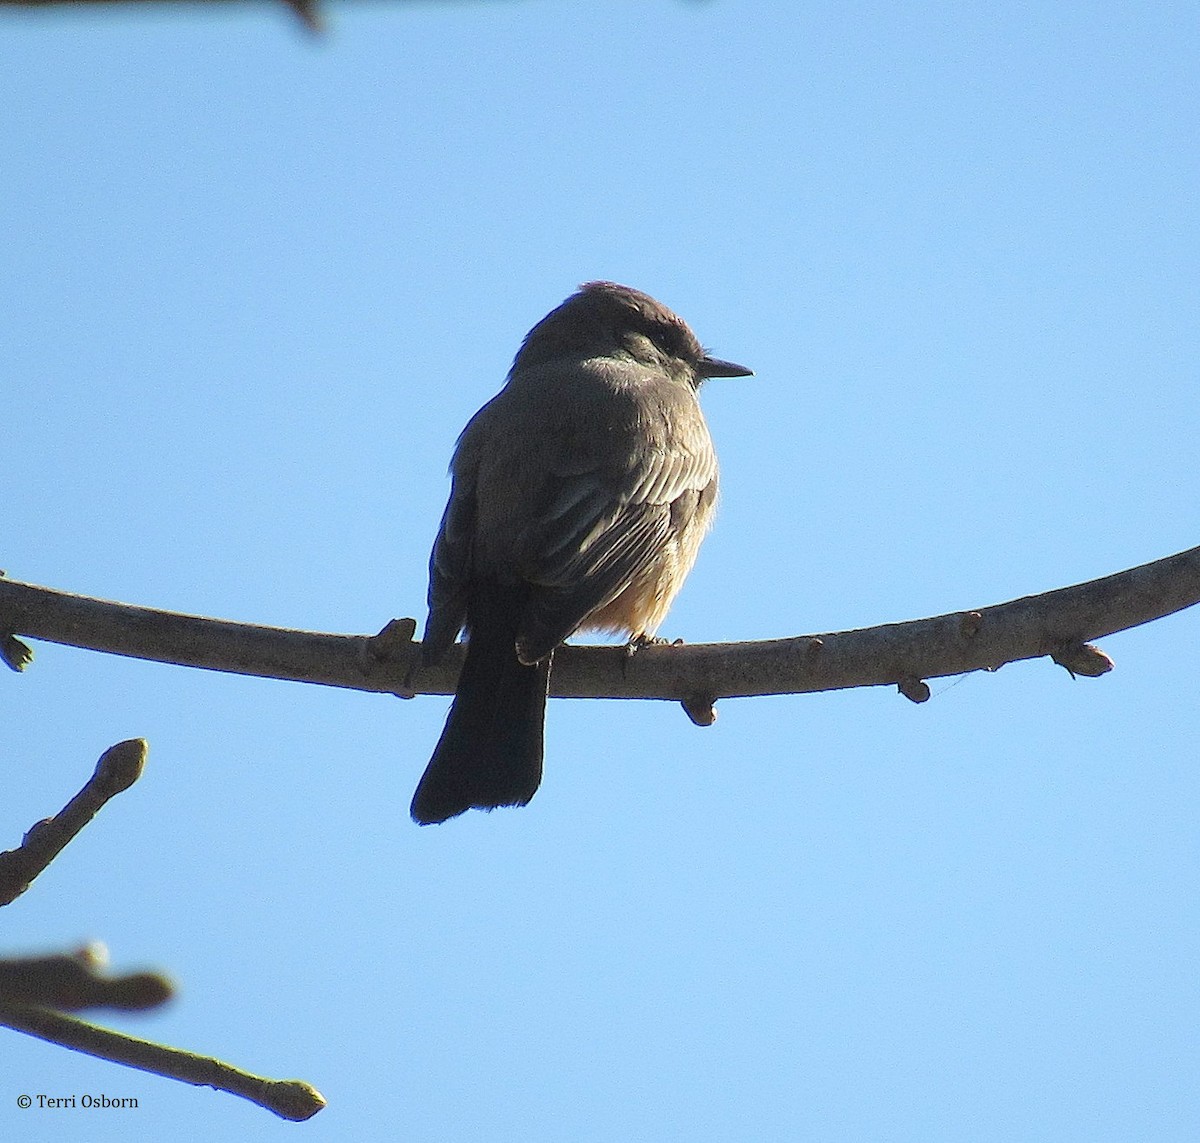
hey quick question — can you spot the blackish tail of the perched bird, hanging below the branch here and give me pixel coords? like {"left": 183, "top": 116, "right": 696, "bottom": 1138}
{"left": 412, "top": 588, "right": 552, "bottom": 825}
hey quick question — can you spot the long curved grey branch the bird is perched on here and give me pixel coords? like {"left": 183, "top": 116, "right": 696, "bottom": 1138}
{"left": 0, "top": 547, "right": 1200, "bottom": 723}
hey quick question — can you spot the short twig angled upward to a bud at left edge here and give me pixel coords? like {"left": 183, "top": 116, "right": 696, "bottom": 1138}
{"left": 0, "top": 738, "right": 148, "bottom": 905}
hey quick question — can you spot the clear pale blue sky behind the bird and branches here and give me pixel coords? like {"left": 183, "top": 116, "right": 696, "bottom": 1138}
{"left": 0, "top": 0, "right": 1200, "bottom": 1143}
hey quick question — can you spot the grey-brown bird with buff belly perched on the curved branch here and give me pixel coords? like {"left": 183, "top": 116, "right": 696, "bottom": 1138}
{"left": 412, "top": 282, "right": 751, "bottom": 825}
